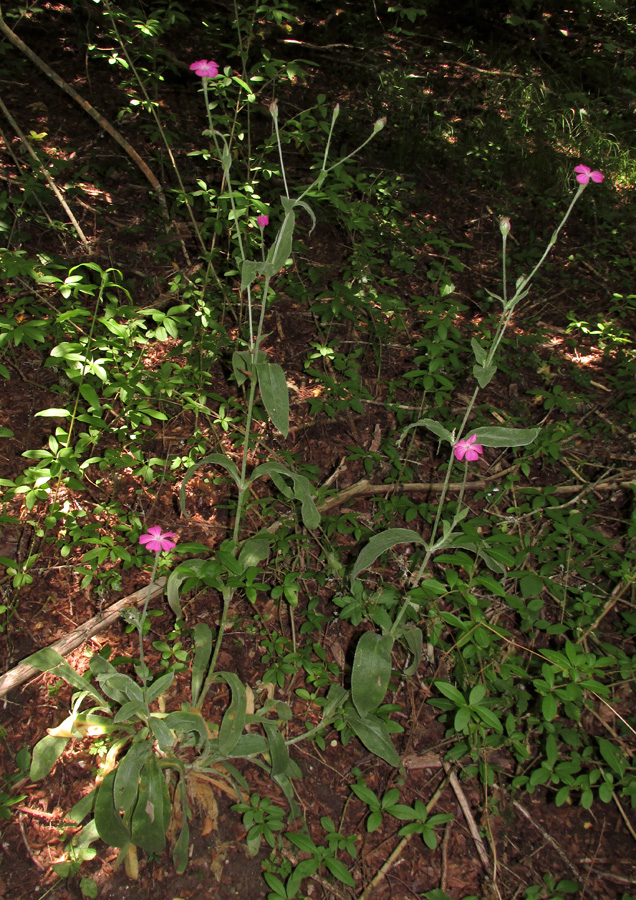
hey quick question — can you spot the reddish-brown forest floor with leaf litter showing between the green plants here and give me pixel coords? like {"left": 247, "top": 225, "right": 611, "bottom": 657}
{"left": 0, "top": 4, "right": 636, "bottom": 900}
